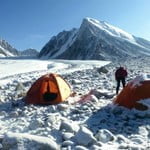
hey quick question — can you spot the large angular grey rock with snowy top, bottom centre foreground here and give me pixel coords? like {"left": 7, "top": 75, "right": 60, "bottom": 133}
{"left": 74, "top": 127, "right": 96, "bottom": 146}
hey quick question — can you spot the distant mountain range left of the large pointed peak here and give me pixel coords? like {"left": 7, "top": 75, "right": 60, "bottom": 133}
{"left": 0, "top": 40, "right": 39, "bottom": 57}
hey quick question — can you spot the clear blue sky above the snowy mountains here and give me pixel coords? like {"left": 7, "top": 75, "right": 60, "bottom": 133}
{"left": 0, "top": 0, "right": 150, "bottom": 50}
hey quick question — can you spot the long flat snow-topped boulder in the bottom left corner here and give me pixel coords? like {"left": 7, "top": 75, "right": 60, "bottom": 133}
{"left": 2, "top": 133, "right": 59, "bottom": 150}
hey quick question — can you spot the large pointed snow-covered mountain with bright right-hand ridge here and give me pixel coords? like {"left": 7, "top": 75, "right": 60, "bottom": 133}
{"left": 39, "top": 18, "right": 150, "bottom": 60}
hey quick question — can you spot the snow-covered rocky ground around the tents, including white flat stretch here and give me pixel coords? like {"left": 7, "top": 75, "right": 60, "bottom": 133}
{"left": 0, "top": 58, "right": 150, "bottom": 150}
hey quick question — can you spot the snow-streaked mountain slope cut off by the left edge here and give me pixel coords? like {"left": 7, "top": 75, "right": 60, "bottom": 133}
{"left": 0, "top": 39, "right": 18, "bottom": 57}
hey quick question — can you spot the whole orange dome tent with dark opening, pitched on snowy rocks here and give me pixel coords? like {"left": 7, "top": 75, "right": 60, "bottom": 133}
{"left": 25, "top": 74, "right": 71, "bottom": 104}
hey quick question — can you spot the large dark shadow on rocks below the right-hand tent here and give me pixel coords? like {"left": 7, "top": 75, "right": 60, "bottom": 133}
{"left": 86, "top": 105, "right": 150, "bottom": 136}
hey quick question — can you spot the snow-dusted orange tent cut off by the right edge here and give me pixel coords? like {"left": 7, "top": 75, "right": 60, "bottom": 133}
{"left": 114, "top": 80, "right": 150, "bottom": 110}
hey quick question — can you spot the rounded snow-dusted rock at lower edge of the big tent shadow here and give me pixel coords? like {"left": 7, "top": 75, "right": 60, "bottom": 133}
{"left": 95, "top": 129, "right": 115, "bottom": 143}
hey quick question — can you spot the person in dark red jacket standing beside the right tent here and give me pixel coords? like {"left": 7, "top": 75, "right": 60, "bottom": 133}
{"left": 115, "top": 67, "right": 128, "bottom": 94}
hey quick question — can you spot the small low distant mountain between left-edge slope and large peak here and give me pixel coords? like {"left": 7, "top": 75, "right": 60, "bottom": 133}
{"left": 20, "top": 48, "right": 39, "bottom": 57}
